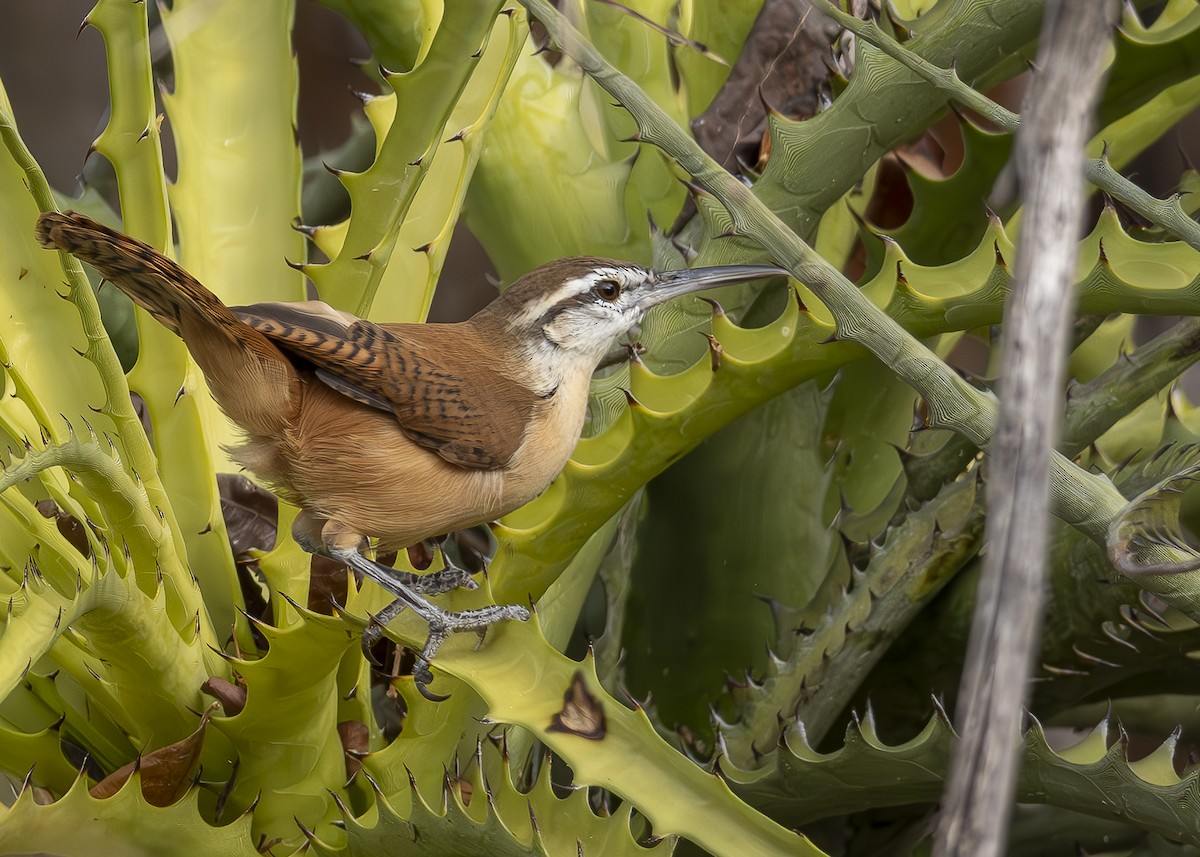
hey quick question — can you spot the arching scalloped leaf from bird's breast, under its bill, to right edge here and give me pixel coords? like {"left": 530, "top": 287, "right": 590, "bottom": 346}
{"left": 493, "top": 193, "right": 1200, "bottom": 600}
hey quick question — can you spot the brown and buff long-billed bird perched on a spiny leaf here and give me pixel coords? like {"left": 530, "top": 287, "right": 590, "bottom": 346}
{"left": 35, "top": 211, "right": 787, "bottom": 699}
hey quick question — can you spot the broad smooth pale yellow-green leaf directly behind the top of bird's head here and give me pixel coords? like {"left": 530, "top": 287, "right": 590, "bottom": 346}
{"left": 466, "top": 0, "right": 688, "bottom": 282}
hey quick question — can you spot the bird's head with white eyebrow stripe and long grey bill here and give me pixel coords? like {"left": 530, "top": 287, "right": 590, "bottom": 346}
{"left": 484, "top": 250, "right": 787, "bottom": 371}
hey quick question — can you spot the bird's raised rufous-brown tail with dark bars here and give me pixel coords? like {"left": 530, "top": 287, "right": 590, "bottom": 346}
{"left": 34, "top": 211, "right": 299, "bottom": 436}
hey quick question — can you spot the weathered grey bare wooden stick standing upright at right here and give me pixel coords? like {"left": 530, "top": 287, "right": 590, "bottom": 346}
{"left": 934, "top": 0, "right": 1117, "bottom": 857}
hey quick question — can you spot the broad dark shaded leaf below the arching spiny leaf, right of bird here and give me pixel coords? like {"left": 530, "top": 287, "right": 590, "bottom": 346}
{"left": 625, "top": 350, "right": 914, "bottom": 744}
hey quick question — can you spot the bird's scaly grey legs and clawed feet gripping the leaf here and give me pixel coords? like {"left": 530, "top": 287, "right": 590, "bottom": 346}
{"left": 330, "top": 549, "right": 529, "bottom": 702}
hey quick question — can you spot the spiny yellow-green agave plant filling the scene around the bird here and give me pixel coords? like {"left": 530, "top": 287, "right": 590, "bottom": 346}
{"left": 0, "top": 0, "right": 1200, "bottom": 856}
